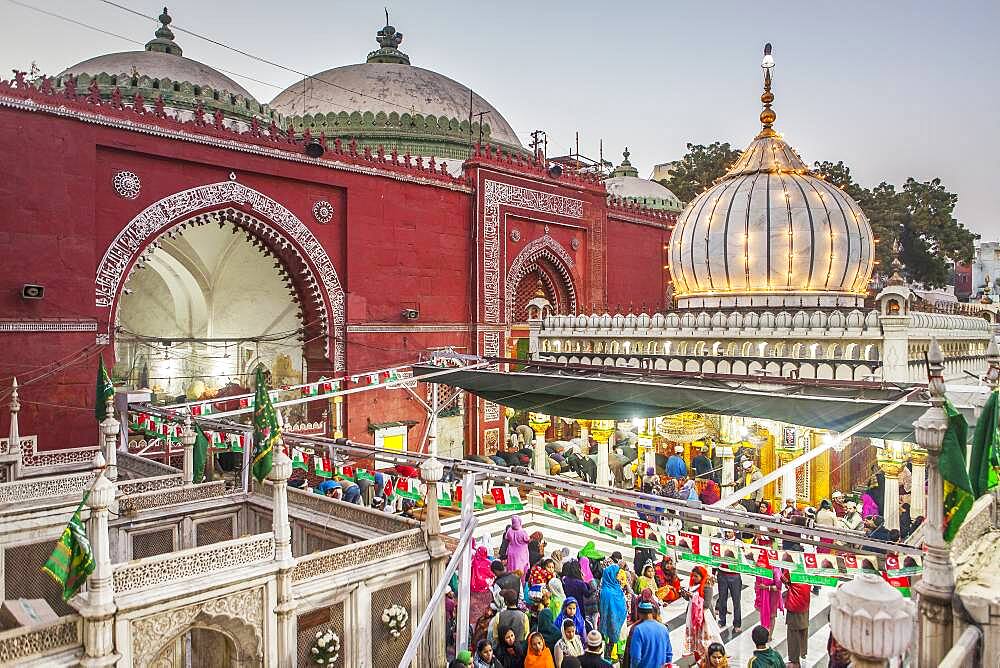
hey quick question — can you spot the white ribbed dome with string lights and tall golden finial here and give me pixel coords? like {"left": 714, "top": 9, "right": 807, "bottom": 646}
{"left": 670, "top": 44, "right": 875, "bottom": 308}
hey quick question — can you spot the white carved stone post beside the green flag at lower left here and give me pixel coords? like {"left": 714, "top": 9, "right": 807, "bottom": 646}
{"left": 74, "top": 452, "right": 119, "bottom": 668}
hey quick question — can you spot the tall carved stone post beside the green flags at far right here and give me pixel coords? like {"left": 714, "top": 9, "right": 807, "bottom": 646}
{"left": 913, "top": 339, "right": 955, "bottom": 666}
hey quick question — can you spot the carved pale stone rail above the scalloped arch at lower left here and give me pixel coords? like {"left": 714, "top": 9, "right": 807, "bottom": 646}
{"left": 114, "top": 533, "right": 274, "bottom": 594}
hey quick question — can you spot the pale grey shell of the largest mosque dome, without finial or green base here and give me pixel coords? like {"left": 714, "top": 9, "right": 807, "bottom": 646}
{"left": 270, "top": 62, "right": 521, "bottom": 147}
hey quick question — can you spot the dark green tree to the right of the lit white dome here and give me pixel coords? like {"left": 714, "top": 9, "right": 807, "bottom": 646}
{"left": 815, "top": 162, "right": 976, "bottom": 287}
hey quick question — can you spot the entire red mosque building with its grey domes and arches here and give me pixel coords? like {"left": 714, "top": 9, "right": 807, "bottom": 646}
{"left": 0, "top": 10, "right": 679, "bottom": 460}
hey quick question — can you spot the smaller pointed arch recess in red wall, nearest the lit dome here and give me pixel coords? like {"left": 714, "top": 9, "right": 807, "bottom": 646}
{"left": 504, "top": 234, "right": 577, "bottom": 323}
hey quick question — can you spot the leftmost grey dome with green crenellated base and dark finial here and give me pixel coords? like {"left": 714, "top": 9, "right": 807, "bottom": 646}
{"left": 56, "top": 8, "right": 272, "bottom": 121}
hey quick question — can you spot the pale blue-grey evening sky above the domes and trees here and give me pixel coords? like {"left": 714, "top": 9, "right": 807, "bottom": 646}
{"left": 0, "top": 0, "right": 1000, "bottom": 239}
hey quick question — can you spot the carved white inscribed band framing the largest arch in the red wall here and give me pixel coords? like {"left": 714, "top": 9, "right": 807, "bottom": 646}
{"left": 95, "top": 180, "right": 345, "bottom": 370}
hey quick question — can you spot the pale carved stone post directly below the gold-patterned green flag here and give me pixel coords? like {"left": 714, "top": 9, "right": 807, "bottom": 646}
{"left": 268, "top": 448, "right": 298, "bottom": 666}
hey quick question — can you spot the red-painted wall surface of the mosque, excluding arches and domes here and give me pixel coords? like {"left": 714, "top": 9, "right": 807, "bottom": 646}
{"left": 0, "top": 91, "right": 666, "bottom": 450}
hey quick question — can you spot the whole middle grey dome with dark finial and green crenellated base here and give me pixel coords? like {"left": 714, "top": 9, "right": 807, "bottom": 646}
{"left": 270, "top": 25, "right": 524, "bottom": 159}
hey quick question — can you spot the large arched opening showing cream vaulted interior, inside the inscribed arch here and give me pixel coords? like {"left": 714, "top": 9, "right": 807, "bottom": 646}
{"left": 115, "top": 208, "right": 308, "bottom": 414}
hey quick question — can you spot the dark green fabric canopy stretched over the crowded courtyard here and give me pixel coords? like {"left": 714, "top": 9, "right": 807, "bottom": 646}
{"left": 413, "top": 365, "right": 929, "bottom": 442}
